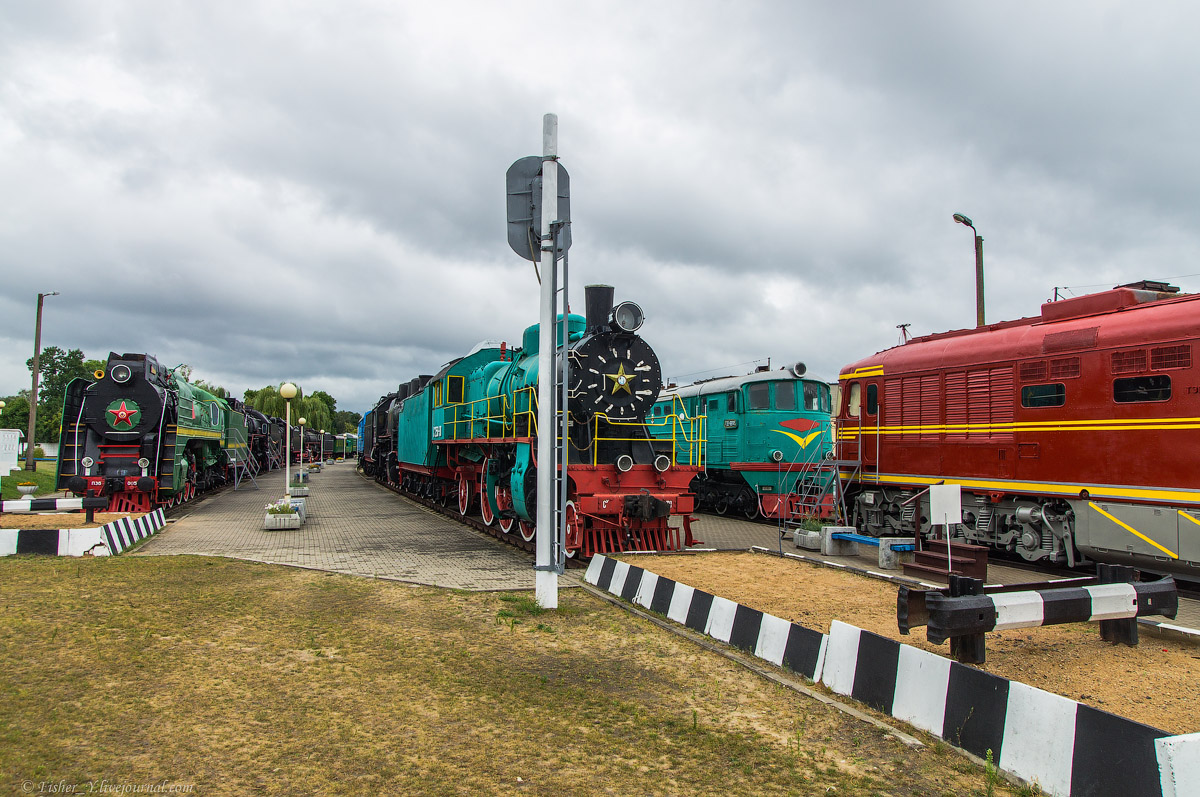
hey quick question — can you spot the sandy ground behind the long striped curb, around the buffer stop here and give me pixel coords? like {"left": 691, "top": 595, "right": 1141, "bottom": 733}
{"left": 629, "top": 553, "right": 1200, "bottom": 733}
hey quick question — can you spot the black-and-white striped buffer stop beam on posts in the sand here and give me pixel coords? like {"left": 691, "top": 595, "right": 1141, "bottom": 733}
{"left": 896, "top": 568, "right": 1180, "bottom": 664}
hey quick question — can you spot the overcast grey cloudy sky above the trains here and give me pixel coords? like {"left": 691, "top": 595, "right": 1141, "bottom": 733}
{"left": 0, "top": 0, "right": 1200, "bottom": 412}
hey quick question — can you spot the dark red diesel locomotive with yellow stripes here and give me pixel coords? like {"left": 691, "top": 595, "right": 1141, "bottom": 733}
{"left": 838, "top": 282, "right": 1200, "bottom": 575}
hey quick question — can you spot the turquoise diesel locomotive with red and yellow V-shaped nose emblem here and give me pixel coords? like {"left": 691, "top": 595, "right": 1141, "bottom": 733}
{"left": 650, "top": 362, "right": 834, "bottom": 520}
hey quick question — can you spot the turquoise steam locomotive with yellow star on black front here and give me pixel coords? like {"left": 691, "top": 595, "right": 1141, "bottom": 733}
{"left": 361, "top": 286, "right": 700, "bottom": 557}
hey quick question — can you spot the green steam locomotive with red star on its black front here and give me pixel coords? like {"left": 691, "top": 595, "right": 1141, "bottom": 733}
{"left": 56, "top": 352, "right": 250, "bottom": 513}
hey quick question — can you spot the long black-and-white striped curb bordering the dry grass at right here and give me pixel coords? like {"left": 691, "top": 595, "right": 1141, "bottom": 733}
{"left": 584, "top": 556, "right": 1200, "bottom": 797}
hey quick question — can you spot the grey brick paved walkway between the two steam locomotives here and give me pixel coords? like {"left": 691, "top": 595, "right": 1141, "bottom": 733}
{"left": 138, "top": 462, "right": 534, "bottom": 591}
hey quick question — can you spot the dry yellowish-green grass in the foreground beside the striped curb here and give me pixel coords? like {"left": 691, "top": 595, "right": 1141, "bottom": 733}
{"left": 0, "top": 557, "right": 1027, "bottom": 796}
